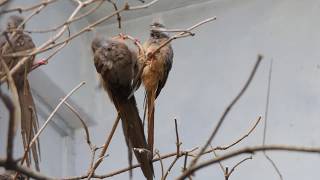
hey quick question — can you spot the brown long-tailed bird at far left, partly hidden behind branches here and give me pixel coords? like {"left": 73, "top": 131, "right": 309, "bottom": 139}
{"left": 0, "top": 16, "right": 40, "bottom": 170}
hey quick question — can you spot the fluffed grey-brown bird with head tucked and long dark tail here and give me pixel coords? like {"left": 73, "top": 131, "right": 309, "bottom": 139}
{"left": 91, "top": 38, "right": 154, "bottom": 180}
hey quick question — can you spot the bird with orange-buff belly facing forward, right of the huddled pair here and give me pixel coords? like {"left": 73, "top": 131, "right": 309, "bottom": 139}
{"left": 141, "top": 22, "right": 173, "bottom": 155}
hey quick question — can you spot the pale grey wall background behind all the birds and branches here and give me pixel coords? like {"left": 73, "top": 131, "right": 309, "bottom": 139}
{"left": 0, "top": 0, "right": 320, "bottom": 180}
